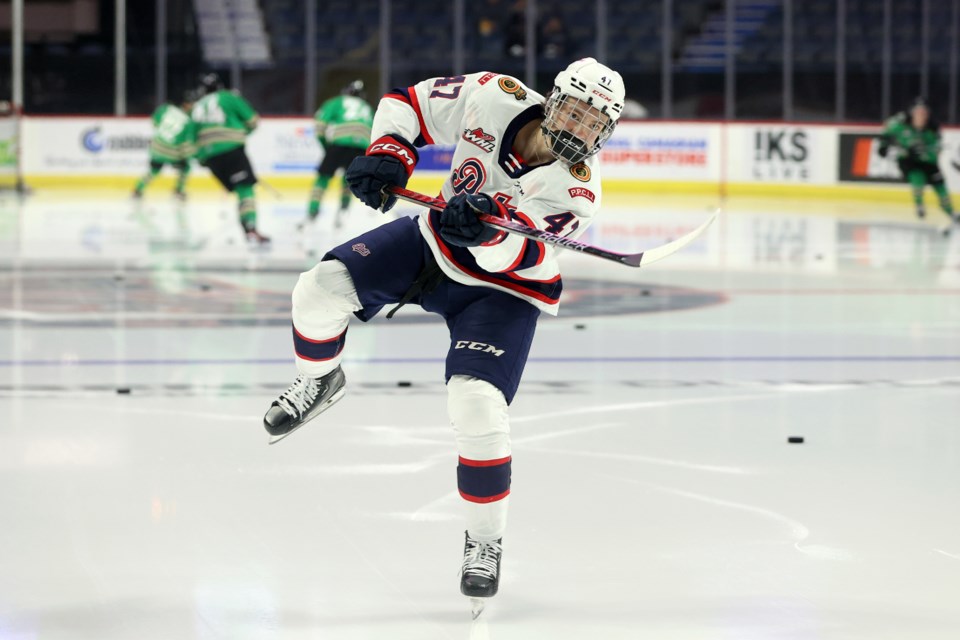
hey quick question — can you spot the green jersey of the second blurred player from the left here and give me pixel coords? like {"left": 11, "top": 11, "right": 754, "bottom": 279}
{"left": 190, "top": 89, "right": 260, "bottom": 163}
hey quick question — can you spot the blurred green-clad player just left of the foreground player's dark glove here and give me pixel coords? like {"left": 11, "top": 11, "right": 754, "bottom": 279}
{"left": 307, "top": 80, "right": 373, "bottom": 227}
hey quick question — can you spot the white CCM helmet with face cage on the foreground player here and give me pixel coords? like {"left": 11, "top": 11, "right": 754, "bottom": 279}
{"left": 540, "top": 58, "right": 626, "bottom": 164}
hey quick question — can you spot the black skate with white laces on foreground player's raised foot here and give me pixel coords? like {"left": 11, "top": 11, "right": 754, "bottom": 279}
{"left": 263, "top": 367, "right": 347, "bottom": 444}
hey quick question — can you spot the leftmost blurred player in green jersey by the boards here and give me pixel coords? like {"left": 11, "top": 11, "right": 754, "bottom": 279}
{"left": 133, "top": 90, "right": 196, "bottom": 200}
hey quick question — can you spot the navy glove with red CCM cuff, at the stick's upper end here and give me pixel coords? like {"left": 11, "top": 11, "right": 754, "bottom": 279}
{"left": 343, "top": 136, "right": 420, "bottom": 211}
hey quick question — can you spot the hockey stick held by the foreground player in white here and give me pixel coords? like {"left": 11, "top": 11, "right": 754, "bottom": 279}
{"left": 389, "top": 187, "right": 720, "bottom": 267}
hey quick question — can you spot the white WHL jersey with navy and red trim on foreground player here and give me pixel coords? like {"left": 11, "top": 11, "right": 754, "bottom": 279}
{"left": 373, "top": 73, "right": 600, "bottom": 315}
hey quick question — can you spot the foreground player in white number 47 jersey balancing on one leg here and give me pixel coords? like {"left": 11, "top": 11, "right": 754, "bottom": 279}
{"left": 264, "top": 58, "right": 625, "bottom": 598}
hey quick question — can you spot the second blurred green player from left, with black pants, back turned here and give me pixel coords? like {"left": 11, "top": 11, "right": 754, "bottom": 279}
{"left": 190, "top": 73, "right": 270, "bottom": 244}
